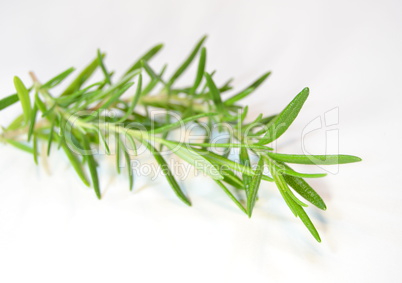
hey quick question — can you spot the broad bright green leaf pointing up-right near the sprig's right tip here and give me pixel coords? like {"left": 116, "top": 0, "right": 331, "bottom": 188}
{"left": 257, "top": 88, "right": 309, "bottom": 144}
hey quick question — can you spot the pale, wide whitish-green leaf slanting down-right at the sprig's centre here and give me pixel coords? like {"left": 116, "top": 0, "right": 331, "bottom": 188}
{"left": 162, "top": 140, "right": 223, "bottom": 180}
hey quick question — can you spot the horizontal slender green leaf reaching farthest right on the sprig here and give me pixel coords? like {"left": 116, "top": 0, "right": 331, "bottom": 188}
{"left": 268, "top": 152, "right": 361, "bottom": 165}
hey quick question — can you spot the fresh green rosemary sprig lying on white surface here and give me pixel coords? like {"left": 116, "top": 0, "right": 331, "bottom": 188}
{"left": 0, "top": 37, "right": 361, "bottom": 241}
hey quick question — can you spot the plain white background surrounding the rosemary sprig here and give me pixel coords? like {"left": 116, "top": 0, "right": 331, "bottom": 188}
{"left": 0, "top": 0, "right": 402, "bottom": 283}
